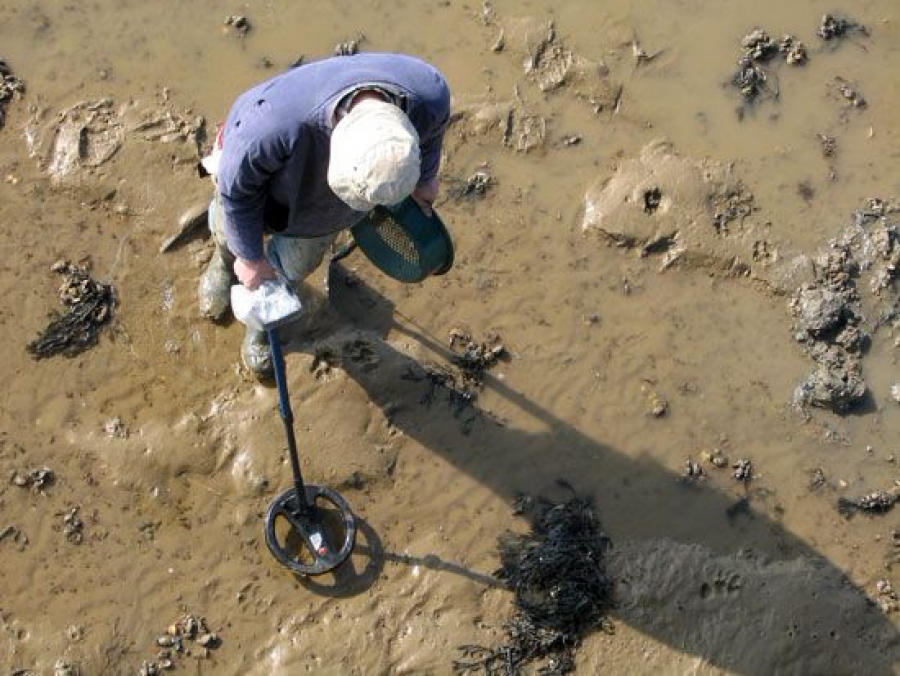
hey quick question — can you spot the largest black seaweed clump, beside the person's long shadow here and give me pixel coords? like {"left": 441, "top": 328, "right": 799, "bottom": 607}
{"left": 453, "top": 494, "right": 613, "bottom": 676}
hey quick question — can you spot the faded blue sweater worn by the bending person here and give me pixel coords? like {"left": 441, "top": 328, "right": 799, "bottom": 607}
{"left": 217, "top": 53, "right": 450, "bottom": 260}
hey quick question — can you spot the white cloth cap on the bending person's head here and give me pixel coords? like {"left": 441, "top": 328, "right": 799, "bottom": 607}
{"left": 328, "top": 99, "right": 421, "bottom": 211}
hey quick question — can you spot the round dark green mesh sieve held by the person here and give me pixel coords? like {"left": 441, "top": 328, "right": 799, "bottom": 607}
{"left": 351, "top": 197, "right": 453, "bottom": 282}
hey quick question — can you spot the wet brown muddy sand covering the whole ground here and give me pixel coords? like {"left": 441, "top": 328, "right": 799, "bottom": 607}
{"left": 0, "top": 0, "right": 900, "bottom": 675}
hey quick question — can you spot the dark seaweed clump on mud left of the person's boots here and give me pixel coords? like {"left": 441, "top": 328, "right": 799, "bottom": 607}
{"left": 26, "top": 261, "right": 115, "bottom": 359}
